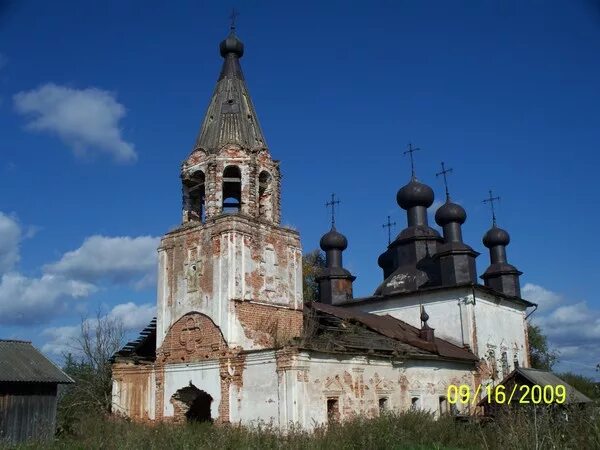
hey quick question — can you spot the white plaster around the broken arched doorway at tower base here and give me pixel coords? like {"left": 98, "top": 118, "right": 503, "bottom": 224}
{"left": 163, "top": 360, "right": 221, "bottom": 419}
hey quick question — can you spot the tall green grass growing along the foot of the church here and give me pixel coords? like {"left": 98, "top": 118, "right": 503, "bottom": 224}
{"left": 9, "top": 408, "right": 600, "bottom": 450}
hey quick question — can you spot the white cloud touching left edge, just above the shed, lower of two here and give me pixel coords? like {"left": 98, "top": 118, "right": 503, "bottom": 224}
{"left": 0, "top": 272, "right": 96, "bottom": 324}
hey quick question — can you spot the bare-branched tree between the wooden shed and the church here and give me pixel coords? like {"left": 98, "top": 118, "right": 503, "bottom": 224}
{"left": 59, "top": 311, "right": 125, "bottom": 428}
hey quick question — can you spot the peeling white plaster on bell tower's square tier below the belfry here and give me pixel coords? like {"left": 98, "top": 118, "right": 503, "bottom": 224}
{"left": 157, "top": 223, "right": 302, "bottom": 350}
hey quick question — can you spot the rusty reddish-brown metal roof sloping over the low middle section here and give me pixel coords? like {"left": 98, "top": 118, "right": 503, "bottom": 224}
{"left": 307, "top": 302, "right": 479, "bottom": 362}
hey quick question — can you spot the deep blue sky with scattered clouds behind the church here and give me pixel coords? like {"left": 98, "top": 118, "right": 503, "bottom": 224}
{"left": 0, "top": 0, "right": 600, "bottom": 376}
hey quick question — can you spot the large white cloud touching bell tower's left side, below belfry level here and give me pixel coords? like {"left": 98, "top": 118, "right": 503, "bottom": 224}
{"left": 44, "top": 235, "right": 159, "bottom": 287}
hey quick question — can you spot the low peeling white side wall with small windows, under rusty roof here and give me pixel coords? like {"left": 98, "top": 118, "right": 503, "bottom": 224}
{"left": 280, "top": 353, "right": 473, "bottom": 429}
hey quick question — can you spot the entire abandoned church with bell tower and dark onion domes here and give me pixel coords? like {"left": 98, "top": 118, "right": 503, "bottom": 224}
{"left": 112, "top": 28, "right": 535, "bottom": 429}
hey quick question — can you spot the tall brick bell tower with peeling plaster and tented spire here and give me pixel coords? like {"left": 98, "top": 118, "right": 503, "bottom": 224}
{"left": 157, "top": 26, "right": 302, "bottom": 349}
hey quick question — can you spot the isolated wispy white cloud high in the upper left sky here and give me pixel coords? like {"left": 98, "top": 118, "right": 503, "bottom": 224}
{"left": 13, "top": 83, "right": 137, "bottom": 163}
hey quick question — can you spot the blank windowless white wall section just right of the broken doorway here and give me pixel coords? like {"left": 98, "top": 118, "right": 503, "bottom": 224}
{"left": 230, "top": 351, "right": 279, "bottom": 426}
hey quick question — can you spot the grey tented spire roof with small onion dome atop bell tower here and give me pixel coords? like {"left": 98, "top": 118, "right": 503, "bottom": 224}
{"left": 193, "top": 31, "right": 267, "bottom": 153}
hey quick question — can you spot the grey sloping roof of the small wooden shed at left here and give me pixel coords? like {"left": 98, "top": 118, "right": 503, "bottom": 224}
{"left": 0, "top": 339, "right": 74, "bottom": 383}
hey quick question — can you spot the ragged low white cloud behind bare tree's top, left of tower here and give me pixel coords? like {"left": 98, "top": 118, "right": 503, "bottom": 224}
{"left": 42, "top": 302, "right": 156, "bottom": 355}
